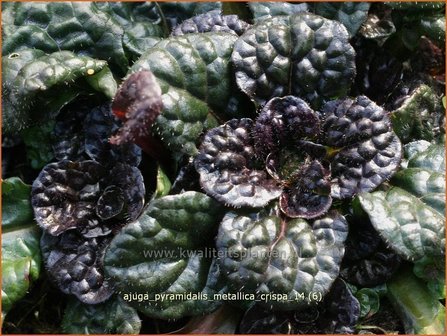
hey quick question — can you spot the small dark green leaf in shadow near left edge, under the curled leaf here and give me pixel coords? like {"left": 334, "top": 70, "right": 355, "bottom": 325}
{"left": 21, "top": 120, "right": 55, "bottom": 169}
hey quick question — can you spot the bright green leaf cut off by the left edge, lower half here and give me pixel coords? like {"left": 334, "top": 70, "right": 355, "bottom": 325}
{"left": 2, "top": 177, "right": 41, "bottom": 317}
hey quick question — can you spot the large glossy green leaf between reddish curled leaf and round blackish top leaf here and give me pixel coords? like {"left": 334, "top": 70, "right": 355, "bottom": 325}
{"left": 130, "top": 33, "right": 247, "bottom": 155}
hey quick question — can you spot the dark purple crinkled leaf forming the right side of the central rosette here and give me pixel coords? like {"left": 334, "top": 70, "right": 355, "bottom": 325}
{"left": 322, "top": 96, "right": 402, "bottom": 199}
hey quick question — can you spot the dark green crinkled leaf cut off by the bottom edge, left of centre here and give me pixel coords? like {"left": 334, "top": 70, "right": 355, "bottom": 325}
{"left": 62, "top": 296, "right": 141, "bottom": 334}
